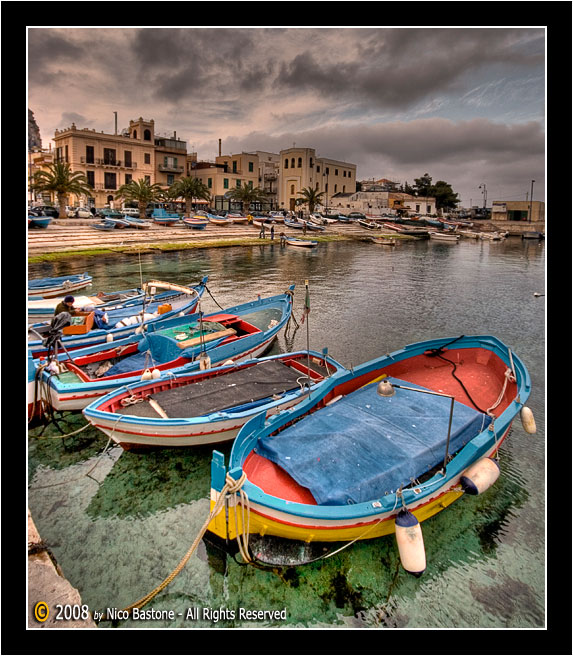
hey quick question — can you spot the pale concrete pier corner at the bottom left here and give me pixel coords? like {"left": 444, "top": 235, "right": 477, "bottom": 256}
{"left": 28, "top": 510, "right": 97, "bottom": 629}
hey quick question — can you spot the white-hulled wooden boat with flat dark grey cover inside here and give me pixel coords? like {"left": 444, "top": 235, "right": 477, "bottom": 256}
{"left": 83, "top": 351, "right": 344, "bottom": 450}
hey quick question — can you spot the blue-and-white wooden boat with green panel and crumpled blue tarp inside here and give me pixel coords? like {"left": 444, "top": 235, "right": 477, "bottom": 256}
{"left": 28, "top": 285, "right": 294, "bottom": 416}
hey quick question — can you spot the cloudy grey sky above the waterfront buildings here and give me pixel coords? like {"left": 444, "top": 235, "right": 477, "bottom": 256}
{"left": 28, "top": 27, "right": 546, "bottom": 206}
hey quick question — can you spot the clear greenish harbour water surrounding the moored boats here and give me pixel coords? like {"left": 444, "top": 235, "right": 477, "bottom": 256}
{"left": 28, "top": 238, "right": 545, "bottom": 628}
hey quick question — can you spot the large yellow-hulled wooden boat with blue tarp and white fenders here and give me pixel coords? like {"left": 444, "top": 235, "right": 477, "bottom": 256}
{"left": 209, "top": 335, "right": 535, "bottom": 575}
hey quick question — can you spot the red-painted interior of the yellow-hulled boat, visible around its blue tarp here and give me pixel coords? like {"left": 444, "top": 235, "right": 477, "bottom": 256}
{"left": 243, "top": 348, "right": 517, "bottom": 505}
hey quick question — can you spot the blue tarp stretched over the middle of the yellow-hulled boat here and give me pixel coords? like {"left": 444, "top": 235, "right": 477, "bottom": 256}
{"left": 256, "top": 378, "right": 490, "bottom": 505}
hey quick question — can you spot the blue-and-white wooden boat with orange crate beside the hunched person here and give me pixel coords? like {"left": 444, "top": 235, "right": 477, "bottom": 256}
{"left": 28, "top": 276, "right": 208, "bottom": 358}
